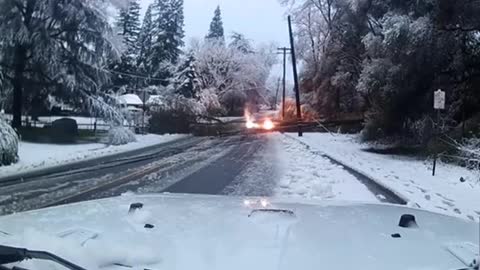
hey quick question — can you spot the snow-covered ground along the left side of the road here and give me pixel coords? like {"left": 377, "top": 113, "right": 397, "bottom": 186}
{"left": 0, "top": 134, "right": 185, "bottom": 177}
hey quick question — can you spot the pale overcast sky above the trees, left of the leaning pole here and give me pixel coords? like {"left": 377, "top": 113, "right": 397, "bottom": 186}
{"left": 141, "top": 0, "right": 288, "bottom": 45}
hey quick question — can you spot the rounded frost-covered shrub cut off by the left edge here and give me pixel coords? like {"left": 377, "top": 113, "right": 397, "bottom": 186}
{"left": 0, "top": 116, "right": 18, "bottom": 166}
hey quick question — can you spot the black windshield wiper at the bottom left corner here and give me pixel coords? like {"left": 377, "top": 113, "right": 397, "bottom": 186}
{"left": 0, "top": 245, "right": 86, "bottom": 270}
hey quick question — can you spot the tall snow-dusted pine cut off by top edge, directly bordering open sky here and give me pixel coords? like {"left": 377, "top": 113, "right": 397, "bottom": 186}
{"left": 147, "top": 0, "right": 185, "bottom": 77}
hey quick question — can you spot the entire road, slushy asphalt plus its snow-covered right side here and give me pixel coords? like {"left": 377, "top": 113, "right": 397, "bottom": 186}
{"left": 0, "top": 133, "right": 399, "bottom": 214}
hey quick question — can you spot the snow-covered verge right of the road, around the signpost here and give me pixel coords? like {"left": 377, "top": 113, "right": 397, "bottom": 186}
{"left": 286, "top": 133, "right": 480, "bottom": 220}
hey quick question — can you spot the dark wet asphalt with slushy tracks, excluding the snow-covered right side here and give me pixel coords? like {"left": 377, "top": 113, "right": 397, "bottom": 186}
{"left": 0, "top": 134, "right": 401, "bottom": 214}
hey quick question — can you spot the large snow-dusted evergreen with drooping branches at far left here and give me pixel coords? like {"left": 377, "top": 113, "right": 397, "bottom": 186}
{"left": 0, "top": 0, "right": 113, "bottom": 128}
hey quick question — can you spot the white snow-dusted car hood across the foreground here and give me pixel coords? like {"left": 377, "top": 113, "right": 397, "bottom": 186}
{"left": 0, "top": 194, "right": 479, "bottom": 270}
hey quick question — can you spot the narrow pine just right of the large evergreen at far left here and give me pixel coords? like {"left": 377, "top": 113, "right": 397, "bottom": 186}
{"left": 117, "top": 0, "right": 140, "bottom": 55}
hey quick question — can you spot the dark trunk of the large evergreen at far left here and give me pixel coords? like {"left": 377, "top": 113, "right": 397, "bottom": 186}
{"left": 12, "top": 46, "right": 27, "bottom": 129}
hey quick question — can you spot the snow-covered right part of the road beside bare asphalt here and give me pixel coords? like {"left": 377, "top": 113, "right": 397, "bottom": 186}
{"left": 224, "top": 133, "right": 379, "bottom": 202}
